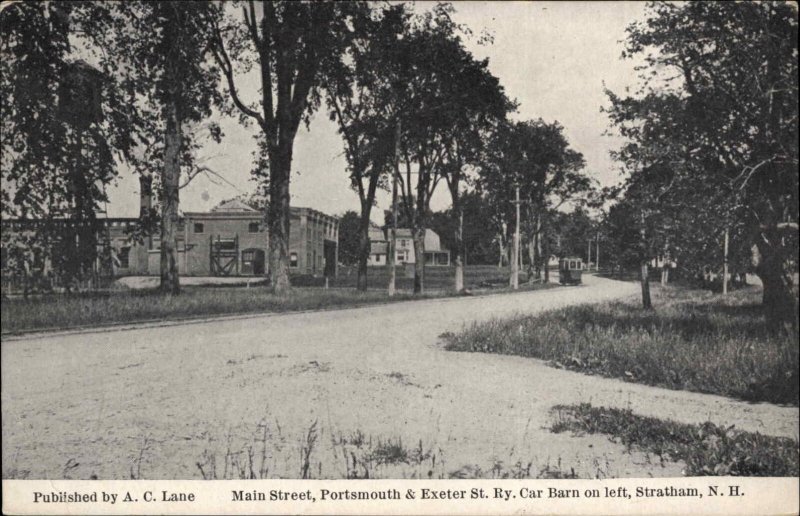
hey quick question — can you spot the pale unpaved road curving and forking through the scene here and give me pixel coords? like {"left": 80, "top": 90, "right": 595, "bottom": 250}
{"left": 2, "top": 276, "right": 798, "bottom": 479}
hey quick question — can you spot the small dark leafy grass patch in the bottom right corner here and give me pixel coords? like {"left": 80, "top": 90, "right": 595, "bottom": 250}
{"left": 551, "top": 403, "right": 800, "bottom": 477}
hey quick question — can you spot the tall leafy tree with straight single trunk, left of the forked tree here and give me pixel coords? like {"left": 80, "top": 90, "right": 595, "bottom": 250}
{"left": 106, "top": 0, "right": 221, "bottom": 294}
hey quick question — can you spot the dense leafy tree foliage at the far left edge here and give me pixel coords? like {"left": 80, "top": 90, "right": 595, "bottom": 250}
{"left": 0, "top": 2, "right": 137, "bottom": 292}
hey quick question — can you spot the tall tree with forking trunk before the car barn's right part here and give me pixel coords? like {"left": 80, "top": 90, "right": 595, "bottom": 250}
{"left": 211, "top": 0, "right": 356, "bottom": 292}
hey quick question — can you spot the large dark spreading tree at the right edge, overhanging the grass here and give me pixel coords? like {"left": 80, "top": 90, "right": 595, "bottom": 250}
{"left": 611, "top": 2, "right": 798, "bottom": 331}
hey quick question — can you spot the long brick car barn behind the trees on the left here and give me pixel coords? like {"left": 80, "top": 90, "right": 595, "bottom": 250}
{"left": 2, "top": 195, "right": 339, "bottom": 284}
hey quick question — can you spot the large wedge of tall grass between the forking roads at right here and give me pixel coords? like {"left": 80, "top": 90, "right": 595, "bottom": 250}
{"left": 441, "top": 287, "right": 800, "bottom": 405}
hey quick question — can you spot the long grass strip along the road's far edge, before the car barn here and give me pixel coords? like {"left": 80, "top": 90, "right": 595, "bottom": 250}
{"left": 0, "top": 278, "right": 552, "bottom": 335}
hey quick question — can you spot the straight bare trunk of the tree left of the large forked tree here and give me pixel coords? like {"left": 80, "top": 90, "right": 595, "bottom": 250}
{"left": 161, "top": 94, "right": 183, "bottom": 294}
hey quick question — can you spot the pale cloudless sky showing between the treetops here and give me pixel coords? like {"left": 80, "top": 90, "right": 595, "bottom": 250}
{"left": 107, "top": 2, "right": 645, "bottom": 222}
